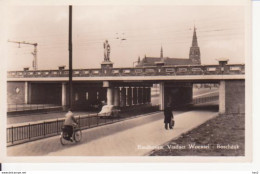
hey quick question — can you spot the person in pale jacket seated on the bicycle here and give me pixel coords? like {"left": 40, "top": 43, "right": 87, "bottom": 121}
{"left": 64, "top": 108, "right": 78, "bottom": 142}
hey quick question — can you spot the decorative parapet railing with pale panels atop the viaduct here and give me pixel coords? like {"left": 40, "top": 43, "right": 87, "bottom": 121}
{"left": 7, "top": 64, "right": 245, "bottom": 78}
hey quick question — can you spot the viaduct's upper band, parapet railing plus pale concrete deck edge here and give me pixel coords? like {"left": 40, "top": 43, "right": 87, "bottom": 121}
{"left": 7, "top": 64, "right": 245, "bottom": 81}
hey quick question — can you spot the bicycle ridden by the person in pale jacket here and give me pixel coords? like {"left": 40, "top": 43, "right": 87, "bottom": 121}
{"left": 60, "top": 125, "right": 82, "bottom": 145}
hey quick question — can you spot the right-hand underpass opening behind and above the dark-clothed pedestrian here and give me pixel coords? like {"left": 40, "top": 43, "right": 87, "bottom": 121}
{"left": 151, "top": 81, "right": 219, "bottom": 112}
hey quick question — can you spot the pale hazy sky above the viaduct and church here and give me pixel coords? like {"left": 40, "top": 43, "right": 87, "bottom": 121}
{"left": 6, "top": 5, "right": 246, "bottom": 70}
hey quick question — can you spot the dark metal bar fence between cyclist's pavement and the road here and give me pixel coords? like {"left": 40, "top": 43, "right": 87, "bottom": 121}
{"left": 6, "top": 106, "right": 158, "bottom": 146}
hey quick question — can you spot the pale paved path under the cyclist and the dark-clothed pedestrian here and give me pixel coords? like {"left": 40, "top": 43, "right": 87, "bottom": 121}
{"left": 7, "top": 110, "right": 217, "bottom": 156}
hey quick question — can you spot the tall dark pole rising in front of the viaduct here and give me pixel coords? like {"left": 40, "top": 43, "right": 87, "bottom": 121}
{"left": 69, "top": 5, "right": 73, "bottom": 109}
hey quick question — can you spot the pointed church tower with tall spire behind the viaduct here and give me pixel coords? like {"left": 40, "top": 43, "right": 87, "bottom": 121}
{"left": 189, "top": 26, "right": 201, "bottom": 65}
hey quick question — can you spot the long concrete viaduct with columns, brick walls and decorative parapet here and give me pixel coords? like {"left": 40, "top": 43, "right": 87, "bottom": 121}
{"left": 7, "top": 61, "right": 245, "bottom": 113}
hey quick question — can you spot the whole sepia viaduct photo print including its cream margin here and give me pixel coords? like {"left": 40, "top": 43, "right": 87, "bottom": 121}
{"left": 2, "top": 0, "right": 252, "bottom": 162}
